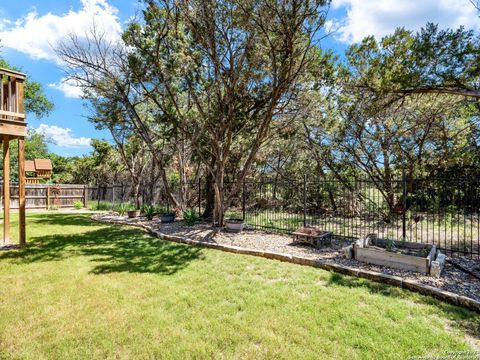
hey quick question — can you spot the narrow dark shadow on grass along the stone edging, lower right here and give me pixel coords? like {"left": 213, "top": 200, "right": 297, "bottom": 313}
{"left": 327, "top": 273, "right": 480, "bottom": 344}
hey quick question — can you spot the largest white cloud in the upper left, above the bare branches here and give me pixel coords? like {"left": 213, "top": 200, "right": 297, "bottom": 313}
{"left": 0, "top": 0, "right": 121, "bottom": 63}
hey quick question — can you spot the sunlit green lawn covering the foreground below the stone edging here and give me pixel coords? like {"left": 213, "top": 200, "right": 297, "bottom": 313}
{"left": 0, "top": 213, "right": 480, "bottom": 359}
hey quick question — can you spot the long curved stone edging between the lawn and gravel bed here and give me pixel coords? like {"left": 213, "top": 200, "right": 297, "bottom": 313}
{"left": 91, "top": 216, "right": 480, "bottom": 312}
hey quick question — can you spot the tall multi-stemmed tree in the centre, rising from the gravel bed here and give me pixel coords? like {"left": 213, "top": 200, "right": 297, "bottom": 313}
{"left": 124, "top": 0, "right": 329, "bottom": 224}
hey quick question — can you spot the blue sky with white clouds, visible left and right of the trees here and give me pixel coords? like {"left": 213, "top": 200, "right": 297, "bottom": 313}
{"left": 0, "top": 0, "right": 480, "bottom": 155}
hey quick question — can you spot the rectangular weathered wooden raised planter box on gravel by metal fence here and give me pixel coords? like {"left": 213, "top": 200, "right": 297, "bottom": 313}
{"left": 353, "top": 236, "right": 437, "bottom": 275}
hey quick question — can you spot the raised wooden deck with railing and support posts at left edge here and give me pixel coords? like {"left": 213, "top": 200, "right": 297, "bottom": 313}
{"left": 0, "top": 68, "right": 27, "bottom": 247}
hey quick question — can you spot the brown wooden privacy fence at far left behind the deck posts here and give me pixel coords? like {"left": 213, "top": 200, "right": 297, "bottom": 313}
{"left": 0, "top": 184, "right": 88, "bottom": 209}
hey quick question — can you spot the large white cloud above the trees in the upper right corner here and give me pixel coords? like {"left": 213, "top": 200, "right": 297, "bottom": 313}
{"left": 329, "top": 0, "right": 480, "bottom": 43}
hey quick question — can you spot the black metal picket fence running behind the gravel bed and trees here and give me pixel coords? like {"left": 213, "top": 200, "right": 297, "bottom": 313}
{"left": 89, "top": 177, "right": 480, "bottom": 258}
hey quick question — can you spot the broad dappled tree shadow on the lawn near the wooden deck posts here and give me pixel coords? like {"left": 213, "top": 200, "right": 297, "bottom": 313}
{"left": 0, "top": 225, "right": 202, "bottom": 275}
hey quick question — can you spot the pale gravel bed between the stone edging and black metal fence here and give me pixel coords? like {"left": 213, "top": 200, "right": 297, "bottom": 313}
{"left": 94, "top": 214, "right": 480, "bottom": 301}
